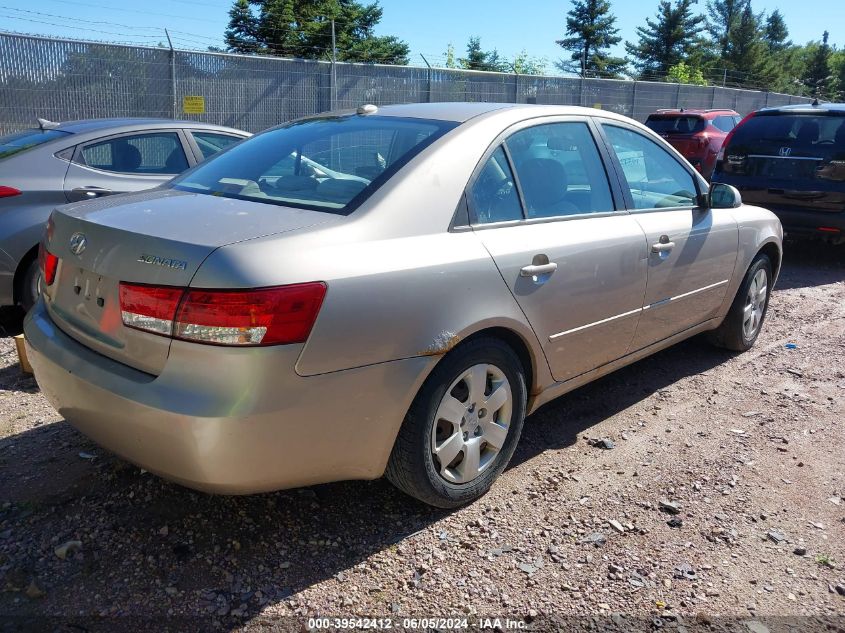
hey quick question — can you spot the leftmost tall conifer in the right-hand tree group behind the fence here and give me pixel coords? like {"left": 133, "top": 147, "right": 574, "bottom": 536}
{"left": 556, "top": 0, "right": 627, "bottom": 77}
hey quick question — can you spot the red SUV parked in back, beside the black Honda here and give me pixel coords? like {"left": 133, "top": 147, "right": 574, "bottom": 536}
{"left": 645, "top": 108, "right": 742, "bottom": 180}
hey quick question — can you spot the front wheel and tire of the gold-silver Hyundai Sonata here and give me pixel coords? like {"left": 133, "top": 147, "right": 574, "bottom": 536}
{"left": 710, "top": 253, "right": 772, "bottom": 352}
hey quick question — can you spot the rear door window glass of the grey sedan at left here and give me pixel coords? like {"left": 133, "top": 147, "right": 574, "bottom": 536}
{"left": 82, "top": 132, "right": 188, "bottom": 175}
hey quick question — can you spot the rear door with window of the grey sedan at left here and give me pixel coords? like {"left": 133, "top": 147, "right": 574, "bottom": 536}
{"left": 64, "top": 130, "right": 193, "bottom": 202}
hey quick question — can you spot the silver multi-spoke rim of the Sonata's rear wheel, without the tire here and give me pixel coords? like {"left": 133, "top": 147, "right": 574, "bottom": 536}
{"left": 431, "top": 364, "right": 513, "bottom": 484}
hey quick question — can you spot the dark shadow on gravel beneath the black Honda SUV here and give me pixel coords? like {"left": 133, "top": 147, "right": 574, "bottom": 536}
{"left": 775, "top": 240, "right": 845, "bottom": 290}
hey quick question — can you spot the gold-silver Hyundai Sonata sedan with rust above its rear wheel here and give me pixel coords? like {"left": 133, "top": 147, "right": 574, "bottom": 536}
{"left": 25, "top": 103, "right": 782, "bottom": 507}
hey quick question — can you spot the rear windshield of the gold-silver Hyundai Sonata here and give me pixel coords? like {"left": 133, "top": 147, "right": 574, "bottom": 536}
{"left": 173, "top": 116, "right": 456, "bottom": 214}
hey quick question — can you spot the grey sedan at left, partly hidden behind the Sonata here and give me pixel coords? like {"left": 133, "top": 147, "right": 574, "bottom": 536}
{"left": 0, "top": 119, "right": 249, "bottom": 309}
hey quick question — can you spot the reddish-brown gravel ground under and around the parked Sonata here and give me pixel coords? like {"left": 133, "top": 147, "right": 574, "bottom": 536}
{"left": 0, "top": 239, "right": 845, "bottom": 631}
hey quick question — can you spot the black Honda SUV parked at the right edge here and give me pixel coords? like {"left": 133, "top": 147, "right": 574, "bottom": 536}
{"left": 713, "top": 103, "right": 845, "bottom": 243}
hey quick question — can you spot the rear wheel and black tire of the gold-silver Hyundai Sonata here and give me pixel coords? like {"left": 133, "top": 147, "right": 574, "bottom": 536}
{"left": 386, "top": 337, "right": 527, "bottom": 508}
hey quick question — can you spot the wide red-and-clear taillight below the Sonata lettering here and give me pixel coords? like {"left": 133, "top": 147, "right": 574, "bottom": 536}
{"left": 120, "top": 282, "right": 326, "bottom": 345}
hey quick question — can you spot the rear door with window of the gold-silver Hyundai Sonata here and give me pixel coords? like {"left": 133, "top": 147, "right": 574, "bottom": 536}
{"left": 467, "top": 117, "right": 646, "bottom": 381}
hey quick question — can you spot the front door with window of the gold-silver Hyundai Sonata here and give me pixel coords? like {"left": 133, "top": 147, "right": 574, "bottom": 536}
{"left": 601, "top": 122, "right": 739, "bottom": 350}
